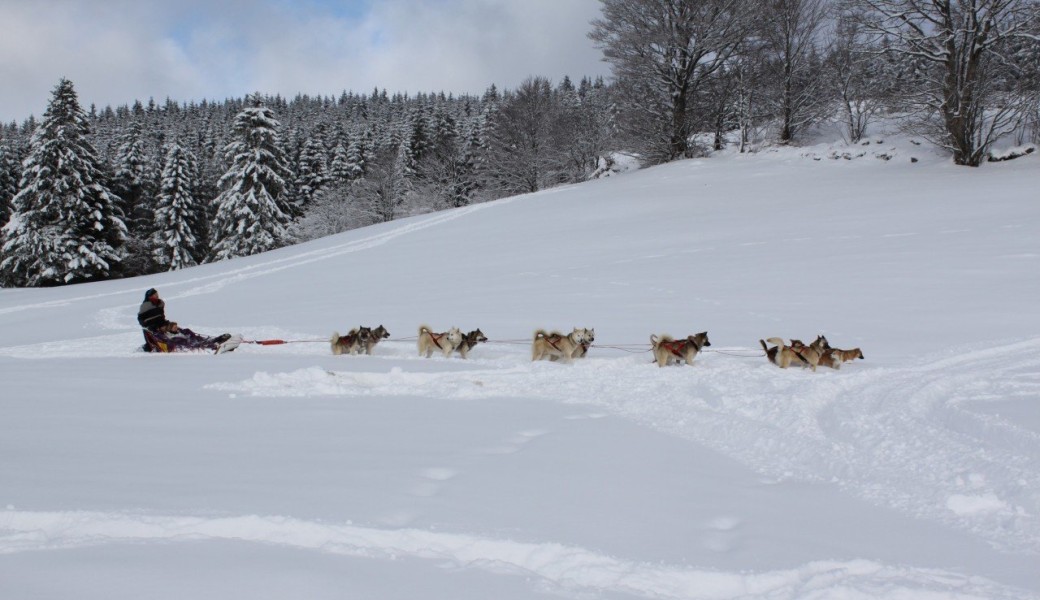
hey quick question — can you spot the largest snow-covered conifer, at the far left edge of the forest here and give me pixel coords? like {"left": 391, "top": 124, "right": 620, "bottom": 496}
{"left": 0, "top": 79, "right": 127, "bottom": 286}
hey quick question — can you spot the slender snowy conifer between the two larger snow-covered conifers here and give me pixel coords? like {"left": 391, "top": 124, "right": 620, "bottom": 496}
{"left": 154, "top": 142, "right": 204, "bottom": 270}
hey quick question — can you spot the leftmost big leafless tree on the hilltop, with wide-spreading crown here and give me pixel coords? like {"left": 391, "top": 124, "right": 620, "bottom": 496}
{"left": 589, "top": 0, "right": 752, "bottom": 162}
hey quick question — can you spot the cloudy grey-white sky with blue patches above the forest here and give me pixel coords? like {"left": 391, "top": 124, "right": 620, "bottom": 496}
{"left": 0, "top": 0, "right": 609, "bottom": 123}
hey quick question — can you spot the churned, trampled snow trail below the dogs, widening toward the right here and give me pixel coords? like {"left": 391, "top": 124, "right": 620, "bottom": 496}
{"left": 193, "top": 339, "right": 1040, "bottom": 554}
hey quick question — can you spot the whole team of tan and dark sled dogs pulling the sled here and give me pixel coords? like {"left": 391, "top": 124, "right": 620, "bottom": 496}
{"left": 330, "top": 324, "right": 863, "bottom": 371}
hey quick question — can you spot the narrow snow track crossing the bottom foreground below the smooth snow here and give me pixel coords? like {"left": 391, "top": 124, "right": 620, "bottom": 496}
{"left": 0, "top": 510, "right": 1031, "bottom": 599}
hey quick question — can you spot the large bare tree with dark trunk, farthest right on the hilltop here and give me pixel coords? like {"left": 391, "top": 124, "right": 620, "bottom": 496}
{"left": 853, "top": 0, "right": 1040, "bottom": 166}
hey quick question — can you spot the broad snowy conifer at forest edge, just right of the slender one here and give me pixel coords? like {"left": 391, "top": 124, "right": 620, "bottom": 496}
{"left": 211, "top": 95, "right": 290, "bottom": 260}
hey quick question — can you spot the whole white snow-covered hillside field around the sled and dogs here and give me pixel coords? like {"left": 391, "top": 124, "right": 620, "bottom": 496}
{"left": 0, "top": 139, "right": 1040, "bottom": 600}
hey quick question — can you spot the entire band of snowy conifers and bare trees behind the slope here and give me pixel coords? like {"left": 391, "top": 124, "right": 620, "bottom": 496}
{"left": 0, "top": 0, "right": 1040, "bottom": 286}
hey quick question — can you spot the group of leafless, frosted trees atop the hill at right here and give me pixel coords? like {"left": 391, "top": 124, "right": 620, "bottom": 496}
{"left": 590, "top": 0, "right": 1040, "bottom": 166}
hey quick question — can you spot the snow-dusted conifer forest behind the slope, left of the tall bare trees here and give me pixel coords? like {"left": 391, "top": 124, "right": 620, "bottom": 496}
{"left": 0, "top": 77, "right": 612, "bottom": 286}
